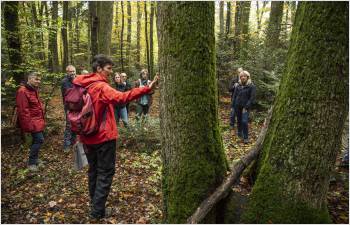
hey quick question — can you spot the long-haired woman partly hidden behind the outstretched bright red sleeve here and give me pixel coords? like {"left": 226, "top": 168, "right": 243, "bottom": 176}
{"left": 114, "top": 72, "right": 128, "bottom": 127}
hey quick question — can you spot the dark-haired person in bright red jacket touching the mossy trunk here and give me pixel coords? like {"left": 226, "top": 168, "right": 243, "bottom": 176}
{"left": 73, "top": 55, "right": 158, "bottom": 219}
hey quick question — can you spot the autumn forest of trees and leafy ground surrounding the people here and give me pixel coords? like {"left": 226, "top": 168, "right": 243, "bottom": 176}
{"left": 1, "top": 1, "right": 349, "bottom": 224}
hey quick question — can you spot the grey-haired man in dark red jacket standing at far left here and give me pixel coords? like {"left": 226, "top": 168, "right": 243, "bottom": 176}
{"left": 16, "top": 72, "right": 45, "bottom": 171}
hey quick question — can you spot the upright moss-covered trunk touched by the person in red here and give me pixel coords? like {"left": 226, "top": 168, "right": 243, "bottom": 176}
{"left": 157, "top": 2, "right": 227, "bottom": 223}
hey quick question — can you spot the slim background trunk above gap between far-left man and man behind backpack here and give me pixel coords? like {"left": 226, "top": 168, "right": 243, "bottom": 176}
{"left": 49, "top": 1, "right": 60, "bottom": 73}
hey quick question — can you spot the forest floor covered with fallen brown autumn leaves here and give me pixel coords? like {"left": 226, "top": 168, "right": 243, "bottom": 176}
{"left": 1, "top": 88, "right": 349, "bottom": 223}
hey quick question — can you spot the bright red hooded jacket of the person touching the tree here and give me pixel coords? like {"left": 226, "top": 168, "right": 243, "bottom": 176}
{"left": 73, "top": 73, "right": 151, "bottom": 144}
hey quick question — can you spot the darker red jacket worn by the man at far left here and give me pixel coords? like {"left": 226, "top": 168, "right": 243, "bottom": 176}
{"left": 16, "top": 84, "right": 45, "bottom": 133}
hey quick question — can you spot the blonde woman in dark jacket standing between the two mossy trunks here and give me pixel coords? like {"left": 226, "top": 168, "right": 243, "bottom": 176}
{"left": 232, "top": 71, "right": 256, "bottom": 144}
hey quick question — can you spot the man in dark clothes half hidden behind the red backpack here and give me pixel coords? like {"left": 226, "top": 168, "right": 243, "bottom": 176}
{"left": 61, "top": 65, "right": 76, "bottom": 152}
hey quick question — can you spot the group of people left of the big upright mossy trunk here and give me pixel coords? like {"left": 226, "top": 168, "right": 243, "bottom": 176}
{"left": 16, "top": 54, "right": 159, "bottom": 219}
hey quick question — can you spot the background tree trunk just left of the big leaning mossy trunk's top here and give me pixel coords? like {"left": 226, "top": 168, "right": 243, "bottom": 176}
{"left": 265, "top": 1, "right": 284, "bottom": 48}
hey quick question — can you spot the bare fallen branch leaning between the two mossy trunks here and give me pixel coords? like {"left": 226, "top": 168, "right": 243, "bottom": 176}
{"left": 187, "top": 107, "right": 273, "bottom": 224}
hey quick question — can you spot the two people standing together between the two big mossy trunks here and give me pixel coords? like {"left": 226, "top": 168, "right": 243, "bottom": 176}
{"left": 229, "top": 68, "right": 256, "bottom": 144}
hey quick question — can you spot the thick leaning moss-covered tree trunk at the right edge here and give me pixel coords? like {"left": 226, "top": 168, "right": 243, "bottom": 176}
{"left": 243, "top": 2, "right": 349, "bottom": 223}
